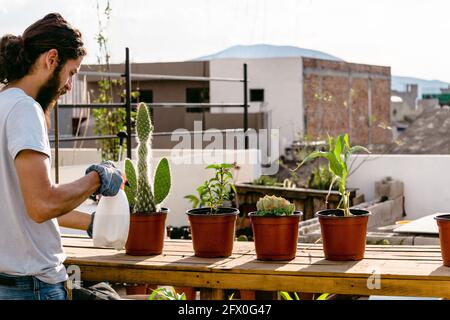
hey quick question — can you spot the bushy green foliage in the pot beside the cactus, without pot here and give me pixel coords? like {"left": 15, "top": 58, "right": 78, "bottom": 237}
{"left": 184, "top": 163, "right": 236, "bottom": 214}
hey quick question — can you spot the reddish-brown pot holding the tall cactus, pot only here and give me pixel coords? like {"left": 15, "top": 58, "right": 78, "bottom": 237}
{"left": 125, "top": 208, "right": 169, "bottom": 256}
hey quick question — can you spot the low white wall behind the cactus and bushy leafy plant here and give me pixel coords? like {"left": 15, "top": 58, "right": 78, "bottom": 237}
{"left": 53, "top": 150, "right": 260, "bottom": 226}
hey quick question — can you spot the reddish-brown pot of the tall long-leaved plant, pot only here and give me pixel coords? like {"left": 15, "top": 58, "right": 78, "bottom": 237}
{"left": 316, "top": 209, "right": 370, "bottom": 261}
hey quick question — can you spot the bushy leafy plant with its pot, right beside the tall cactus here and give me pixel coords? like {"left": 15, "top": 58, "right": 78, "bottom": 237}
{"left": 185, "top": 164, "right": 239, "bottom": 258}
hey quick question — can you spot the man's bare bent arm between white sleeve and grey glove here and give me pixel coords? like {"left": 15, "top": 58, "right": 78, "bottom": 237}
{"left": 15, "top": 150, "right": 100, "bottom": 223}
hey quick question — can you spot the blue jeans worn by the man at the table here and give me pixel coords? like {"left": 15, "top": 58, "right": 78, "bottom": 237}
{"left": 0, "top": 273, "right": 68, "bottom": 300}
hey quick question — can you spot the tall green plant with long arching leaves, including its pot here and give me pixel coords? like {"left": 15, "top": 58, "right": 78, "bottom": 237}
{"left": 294, "top": 134, "right": 370, "bottom": 260}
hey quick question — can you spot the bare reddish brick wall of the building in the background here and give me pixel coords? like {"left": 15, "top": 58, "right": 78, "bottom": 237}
{"left": 303, "top": 58, "right": 392, "bottom": 145}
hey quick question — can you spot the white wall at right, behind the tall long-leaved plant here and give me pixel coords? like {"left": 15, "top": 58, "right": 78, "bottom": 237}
{"left": 348, "top": 155, "right": 450, "bottom": 219}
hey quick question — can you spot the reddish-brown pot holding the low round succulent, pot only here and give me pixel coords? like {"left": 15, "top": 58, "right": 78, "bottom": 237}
{"left": 249, "top": 211, "right": 303, "bottom": 260}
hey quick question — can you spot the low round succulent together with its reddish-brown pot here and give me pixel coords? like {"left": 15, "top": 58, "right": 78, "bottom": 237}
{"left": 249, "top": 196, "right": 303, "bottom": 260}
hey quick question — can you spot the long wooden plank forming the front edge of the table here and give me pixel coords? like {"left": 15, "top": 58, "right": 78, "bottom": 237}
{"left": 71, "top": 266, "right": 450, "bottom": 298}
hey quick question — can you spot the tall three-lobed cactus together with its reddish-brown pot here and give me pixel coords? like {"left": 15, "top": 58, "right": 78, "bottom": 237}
{"left": 125, "top": 103, "right": 171, "bottom": 256}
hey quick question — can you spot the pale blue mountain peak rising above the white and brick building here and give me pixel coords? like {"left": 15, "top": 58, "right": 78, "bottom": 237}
{"left": 193, "top": 44, "right": 343, "bottom": 61}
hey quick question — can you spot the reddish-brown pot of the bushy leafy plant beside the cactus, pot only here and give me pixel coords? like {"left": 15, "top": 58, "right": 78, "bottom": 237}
{"left": 186, "top": 208, "right": 239, "bottom": 258}
